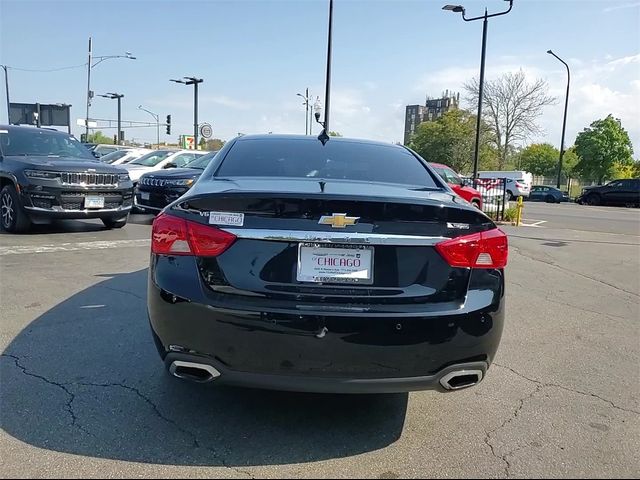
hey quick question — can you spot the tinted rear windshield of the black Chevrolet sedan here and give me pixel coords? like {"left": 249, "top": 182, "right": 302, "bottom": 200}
{"left": 216, "top": 139, "right": 438, "bottom": 188}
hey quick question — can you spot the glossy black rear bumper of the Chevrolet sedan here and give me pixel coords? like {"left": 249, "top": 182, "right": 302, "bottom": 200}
{"left": 148, "top": 257, "right": 504, "bottom": 393}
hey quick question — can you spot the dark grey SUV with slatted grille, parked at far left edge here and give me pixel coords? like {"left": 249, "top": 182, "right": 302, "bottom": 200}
{"left": 0, "top": 125, "right": 133, "bottom": 233}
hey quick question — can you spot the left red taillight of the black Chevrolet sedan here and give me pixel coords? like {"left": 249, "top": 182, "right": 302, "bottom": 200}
{"left": 151, "top": 213, "right": 236, "bottom": 257}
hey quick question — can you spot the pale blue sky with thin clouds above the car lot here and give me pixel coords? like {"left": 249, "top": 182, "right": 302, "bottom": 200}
{"left": 0, "top": 0, "right": 640, "bottom": 153}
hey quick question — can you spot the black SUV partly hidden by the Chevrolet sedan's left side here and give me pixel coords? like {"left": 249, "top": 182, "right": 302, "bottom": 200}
{"left": 135, "top": 151, "right": 218, "bottom": 213}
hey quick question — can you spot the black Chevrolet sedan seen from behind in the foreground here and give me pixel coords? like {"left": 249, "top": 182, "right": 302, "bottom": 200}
{"left": 148, "top": 135, "right": 508, "bottom": 393}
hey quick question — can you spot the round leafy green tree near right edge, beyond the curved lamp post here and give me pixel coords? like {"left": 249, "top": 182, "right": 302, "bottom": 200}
{"left": 575, "top": 115, "right": 633, "bottom": 184}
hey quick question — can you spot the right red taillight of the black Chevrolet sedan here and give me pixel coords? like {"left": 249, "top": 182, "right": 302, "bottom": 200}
{"left": 436, "top": 228, "right": 509, "bottom": 268}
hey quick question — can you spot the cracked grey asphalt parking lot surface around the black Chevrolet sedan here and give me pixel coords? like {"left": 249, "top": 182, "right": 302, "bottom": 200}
{"left": 0, "top": 204, "right": 640, "bottom": 478}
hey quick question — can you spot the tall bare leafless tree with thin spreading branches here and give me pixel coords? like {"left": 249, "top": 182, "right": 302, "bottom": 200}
{"left": 464, "top": 70, "right": 556, "bottom": 169}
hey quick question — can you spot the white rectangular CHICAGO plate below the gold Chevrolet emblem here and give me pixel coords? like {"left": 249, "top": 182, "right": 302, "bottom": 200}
{"left": 296, "top": 242, "right": 375, "bottom": 285}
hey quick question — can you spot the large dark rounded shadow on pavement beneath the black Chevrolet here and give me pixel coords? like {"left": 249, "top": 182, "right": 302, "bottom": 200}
{"left": 0, "top": 270, "right": 408, "bottom": 467}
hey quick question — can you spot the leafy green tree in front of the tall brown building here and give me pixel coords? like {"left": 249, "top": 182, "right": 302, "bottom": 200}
{"left": 409, "top": 109, "right": 499, "bottom": 173}
